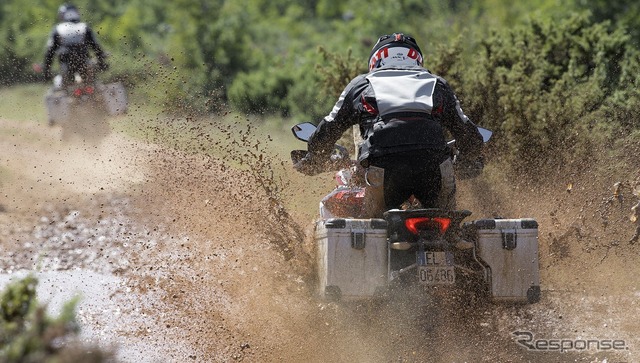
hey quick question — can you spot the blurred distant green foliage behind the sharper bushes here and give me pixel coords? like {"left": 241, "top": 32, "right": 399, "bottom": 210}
{"left": 0, "top": 0, "right": 556, "bottom": 109}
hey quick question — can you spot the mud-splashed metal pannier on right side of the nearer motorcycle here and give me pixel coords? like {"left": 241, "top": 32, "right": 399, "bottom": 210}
{"left": 471, "top": 218, "right": 540, "bottom": 303}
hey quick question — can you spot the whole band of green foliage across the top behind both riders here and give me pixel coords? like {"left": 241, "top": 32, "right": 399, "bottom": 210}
{"left": 0, "top": 0, "right": 640, "bottom": 173}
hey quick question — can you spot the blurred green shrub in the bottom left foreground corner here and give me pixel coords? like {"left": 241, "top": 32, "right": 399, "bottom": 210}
{"left": 0, "top": 276, "right": 108, "bottom": 363}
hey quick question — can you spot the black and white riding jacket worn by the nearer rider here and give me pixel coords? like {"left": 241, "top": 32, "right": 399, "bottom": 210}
{"left": 308, "top": 66, "right": 482, "bottom": 166}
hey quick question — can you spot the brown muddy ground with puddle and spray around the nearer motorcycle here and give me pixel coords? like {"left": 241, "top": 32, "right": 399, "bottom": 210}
{"left": 0, "top": 120, "right": 640, "bottom": 362}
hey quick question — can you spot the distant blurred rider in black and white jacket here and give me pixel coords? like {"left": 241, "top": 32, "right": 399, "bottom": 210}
{"left": 44, "top": 3, "right": 108, "bottom": 87}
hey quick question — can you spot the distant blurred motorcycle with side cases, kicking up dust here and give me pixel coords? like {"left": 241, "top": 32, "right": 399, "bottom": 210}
{"left": 45, "top": 62, "right": 127, "bottom": 141}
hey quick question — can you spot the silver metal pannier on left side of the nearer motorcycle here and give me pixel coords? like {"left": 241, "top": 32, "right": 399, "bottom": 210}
{"left": 315, "top": 218, "right": 387, "bottom": 300}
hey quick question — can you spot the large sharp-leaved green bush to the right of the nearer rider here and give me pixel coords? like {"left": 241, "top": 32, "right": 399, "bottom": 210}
{"left": 465, "top": 14, "right": 639, "bottom": 173}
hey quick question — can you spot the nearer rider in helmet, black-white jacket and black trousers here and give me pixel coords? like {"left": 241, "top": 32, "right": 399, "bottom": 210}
{"left": 294, "top": 33, "right": 483, "bottom": 210}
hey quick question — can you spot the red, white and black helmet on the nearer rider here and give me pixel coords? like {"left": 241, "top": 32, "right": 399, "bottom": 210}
{"left": 369, "top": 33, "right": 422, "bottom": 70}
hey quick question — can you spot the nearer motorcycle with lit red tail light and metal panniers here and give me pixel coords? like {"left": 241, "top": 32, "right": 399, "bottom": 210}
{"left": 291, "top": 122, "right": 541, "bottom": 303}
